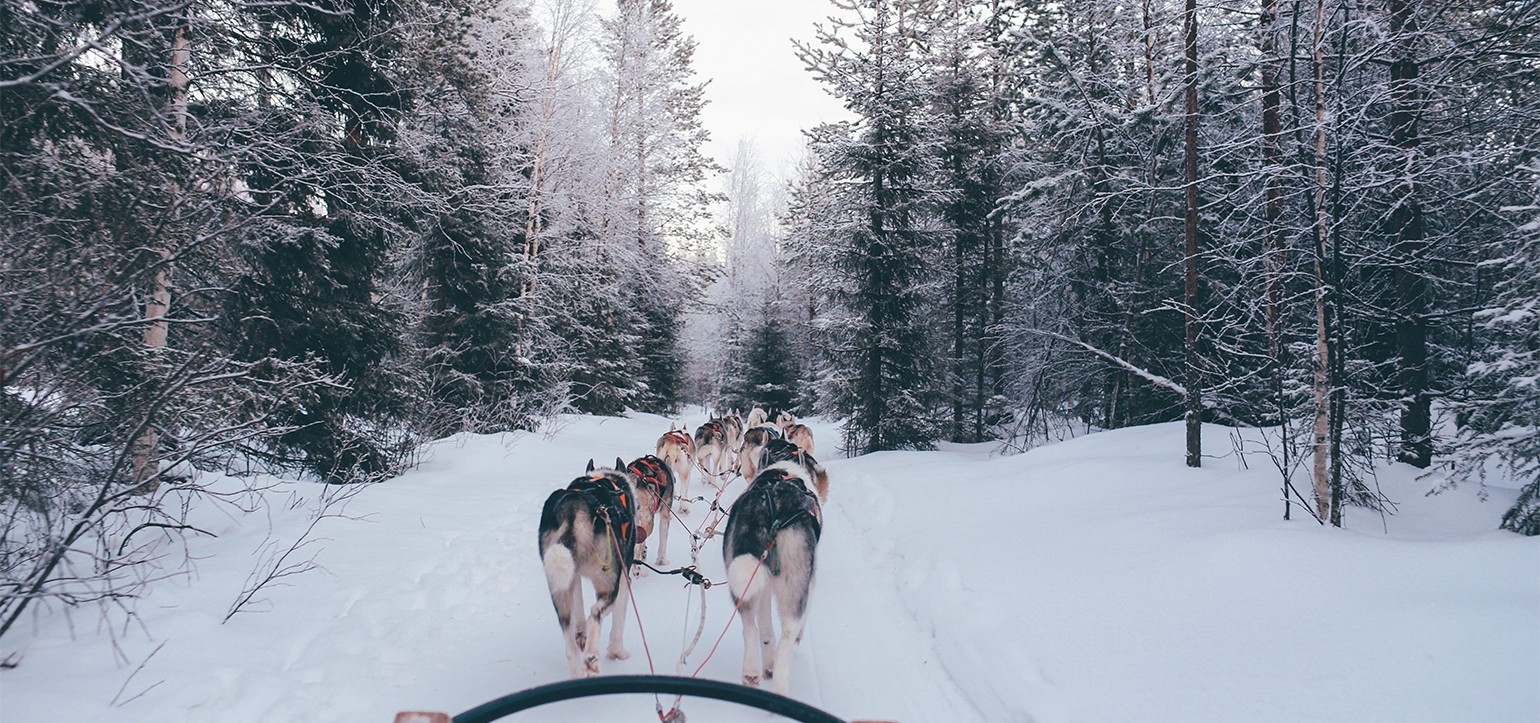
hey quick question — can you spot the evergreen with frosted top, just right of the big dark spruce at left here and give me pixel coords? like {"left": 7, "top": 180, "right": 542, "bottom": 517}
{"left": 402, "top": 0, "right": 544, "bottom": 435}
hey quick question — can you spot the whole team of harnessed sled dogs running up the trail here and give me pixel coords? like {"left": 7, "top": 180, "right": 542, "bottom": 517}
{"left": 539, "top": 407, "right": 829, "bottom": 695}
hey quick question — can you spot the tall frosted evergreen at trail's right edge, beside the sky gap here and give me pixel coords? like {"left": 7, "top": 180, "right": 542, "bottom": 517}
{"left": 799, "top": 0, "right": 944, "bottom": 453}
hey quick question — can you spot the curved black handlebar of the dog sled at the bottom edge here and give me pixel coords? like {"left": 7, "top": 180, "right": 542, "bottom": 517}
{"left": 394, "top": 675, "right": 845, "bottom": 723}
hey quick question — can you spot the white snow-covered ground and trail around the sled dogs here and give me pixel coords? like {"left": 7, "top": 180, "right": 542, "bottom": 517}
{"left": 0, "top": 415, "right": 1540, "bottom": 723}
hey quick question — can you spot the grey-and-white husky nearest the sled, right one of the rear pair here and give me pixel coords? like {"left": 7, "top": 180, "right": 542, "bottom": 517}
{"left": 722, "top": 462, "right": 822, "bottom": 695}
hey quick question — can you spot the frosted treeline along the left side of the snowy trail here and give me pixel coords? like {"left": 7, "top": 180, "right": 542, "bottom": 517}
{"left": 0, "top": 0, "right": 711, "bottom": 635}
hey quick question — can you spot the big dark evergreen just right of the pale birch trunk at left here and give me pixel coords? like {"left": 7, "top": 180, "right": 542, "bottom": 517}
{"left": 226, "top": 0, "right": 420, "bottom": 481}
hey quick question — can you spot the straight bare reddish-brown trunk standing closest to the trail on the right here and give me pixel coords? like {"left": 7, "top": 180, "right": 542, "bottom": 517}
{"left": 1183, "top": 0, "right": 1203, "bottom": 467}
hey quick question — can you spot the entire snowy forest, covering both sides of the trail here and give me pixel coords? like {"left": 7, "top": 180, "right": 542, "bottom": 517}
{"left": 0, "top": 0, "right": 1540, "bottom": 647}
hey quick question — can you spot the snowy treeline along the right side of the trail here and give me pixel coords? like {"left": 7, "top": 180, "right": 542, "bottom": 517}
{"left": 778, "top": 0, "right": 1540, "bottom": 533}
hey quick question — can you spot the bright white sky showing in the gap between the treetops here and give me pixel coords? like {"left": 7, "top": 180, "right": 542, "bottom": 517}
{"left": 673, "top": 0, "right": 847, "bottom": 177}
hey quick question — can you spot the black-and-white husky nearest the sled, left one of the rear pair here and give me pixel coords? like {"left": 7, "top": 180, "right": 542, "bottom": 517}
{"left": 541, "top": 459, "right": 636, "bottom": 678}
